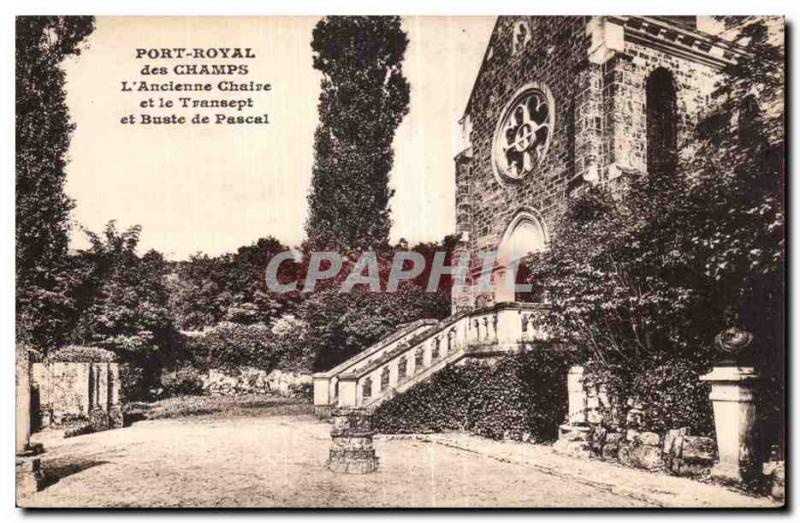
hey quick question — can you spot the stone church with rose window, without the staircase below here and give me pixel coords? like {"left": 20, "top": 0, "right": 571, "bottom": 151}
{"left": 453, "top": 16, "right": 752, "bottom": 312}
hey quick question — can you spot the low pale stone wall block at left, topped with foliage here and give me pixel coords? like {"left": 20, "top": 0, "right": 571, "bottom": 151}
{"left": 32, "top": 362, "right": 123, "bottom": 430}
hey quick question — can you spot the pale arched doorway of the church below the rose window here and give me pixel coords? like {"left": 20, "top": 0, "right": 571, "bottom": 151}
{"left": 493, "top": 208, "right": 547, "bottom": 303}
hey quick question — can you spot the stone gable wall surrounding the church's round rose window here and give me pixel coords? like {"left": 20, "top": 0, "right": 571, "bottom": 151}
{"left": 456, "top": 17, "right": 590, "bottom": 282}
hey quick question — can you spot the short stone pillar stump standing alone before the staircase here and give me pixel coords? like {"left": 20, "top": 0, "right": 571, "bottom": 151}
{"left": 328, "top": 408, "right": 378, "bottom": 474}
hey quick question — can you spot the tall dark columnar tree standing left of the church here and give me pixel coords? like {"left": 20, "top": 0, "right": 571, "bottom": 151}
{"left": 306, "top": 16, "right": 409, "bottom": 250}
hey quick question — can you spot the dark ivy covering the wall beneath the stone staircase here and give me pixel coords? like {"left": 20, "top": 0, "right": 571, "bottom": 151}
{"left": 373, "top": 345, "right": 572, "bottom": 441}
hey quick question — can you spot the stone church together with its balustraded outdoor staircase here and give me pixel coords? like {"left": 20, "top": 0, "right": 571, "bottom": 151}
{"left": 314, "top": 16, "right": 782, "bottom": 422}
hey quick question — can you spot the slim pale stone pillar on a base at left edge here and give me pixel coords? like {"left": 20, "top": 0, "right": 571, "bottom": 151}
{"left": 15, "top": 344, "right": 44, "bottom": 499}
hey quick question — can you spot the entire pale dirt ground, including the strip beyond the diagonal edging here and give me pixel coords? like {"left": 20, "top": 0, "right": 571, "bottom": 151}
{"left": 18, "top": 395, "right": 778, "bottom": 508}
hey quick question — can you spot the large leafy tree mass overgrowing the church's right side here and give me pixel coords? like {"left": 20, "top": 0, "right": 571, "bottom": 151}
{"left": 530, "top": 17, "right": 784, "bottom": 442}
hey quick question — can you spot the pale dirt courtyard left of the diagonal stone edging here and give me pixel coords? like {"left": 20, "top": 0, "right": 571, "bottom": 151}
{"left": 19, "top": 415, "right": 645, "bottom": 507}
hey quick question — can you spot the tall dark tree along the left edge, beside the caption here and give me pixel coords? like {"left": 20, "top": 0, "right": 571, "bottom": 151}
{"left": 16, "top": 16, "right": 94, "bottom": 350}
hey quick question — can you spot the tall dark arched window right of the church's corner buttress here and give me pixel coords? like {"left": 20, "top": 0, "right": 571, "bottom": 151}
{"left": 646, "top": 67, "right": 678, "bottom": 175}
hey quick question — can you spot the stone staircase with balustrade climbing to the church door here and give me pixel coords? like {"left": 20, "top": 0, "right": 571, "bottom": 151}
{"left": 314, "top": 303, "right": 546, "bottom": 417}
